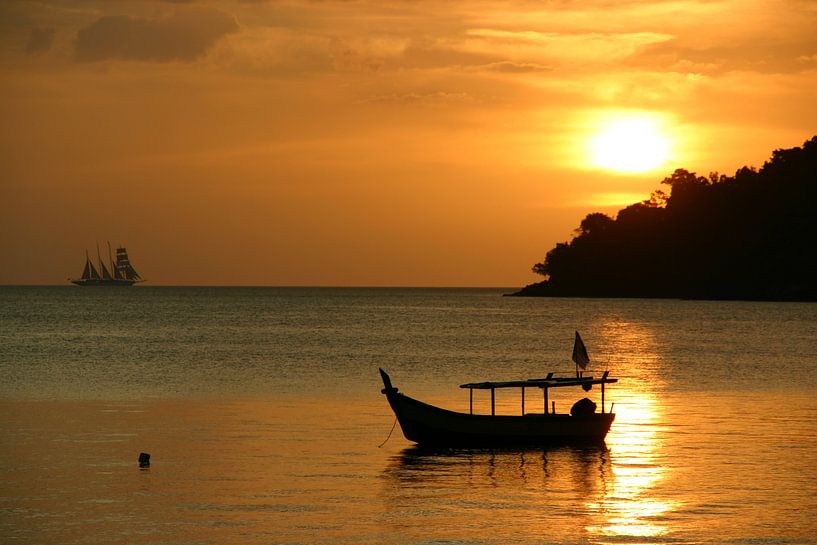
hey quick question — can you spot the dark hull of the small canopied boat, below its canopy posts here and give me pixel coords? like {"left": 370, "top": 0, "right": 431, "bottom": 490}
{"left": 383, "top": 387, "right": 615, "bottom": 447}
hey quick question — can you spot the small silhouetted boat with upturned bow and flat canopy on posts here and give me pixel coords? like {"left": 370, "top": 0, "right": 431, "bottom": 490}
{"left": 380, "top": 369, "right": 618, "bottom": 447}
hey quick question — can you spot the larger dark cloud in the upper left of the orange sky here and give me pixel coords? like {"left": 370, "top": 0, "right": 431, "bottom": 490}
{"left": 75, "top": 7, "right": 238, "bottom": 62}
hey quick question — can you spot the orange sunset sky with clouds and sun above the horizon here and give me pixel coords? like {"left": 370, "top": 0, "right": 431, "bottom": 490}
{"left": 0, "top": 0, "right": 817, "bottom": 287}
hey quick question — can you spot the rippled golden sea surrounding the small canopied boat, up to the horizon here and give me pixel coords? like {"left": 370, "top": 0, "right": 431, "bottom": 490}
{"left": 0, "top": 286, "right": 817, "bottom": 545}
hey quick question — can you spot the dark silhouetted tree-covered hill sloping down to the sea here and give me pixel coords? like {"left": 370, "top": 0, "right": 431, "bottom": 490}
{"left": 513, "top": 136, "right": 817, "bottom": 301}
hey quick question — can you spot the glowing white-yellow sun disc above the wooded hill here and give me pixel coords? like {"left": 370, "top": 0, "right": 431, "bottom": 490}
{"left": 588, "top": 114, "right": 670, "bottom": 173}
